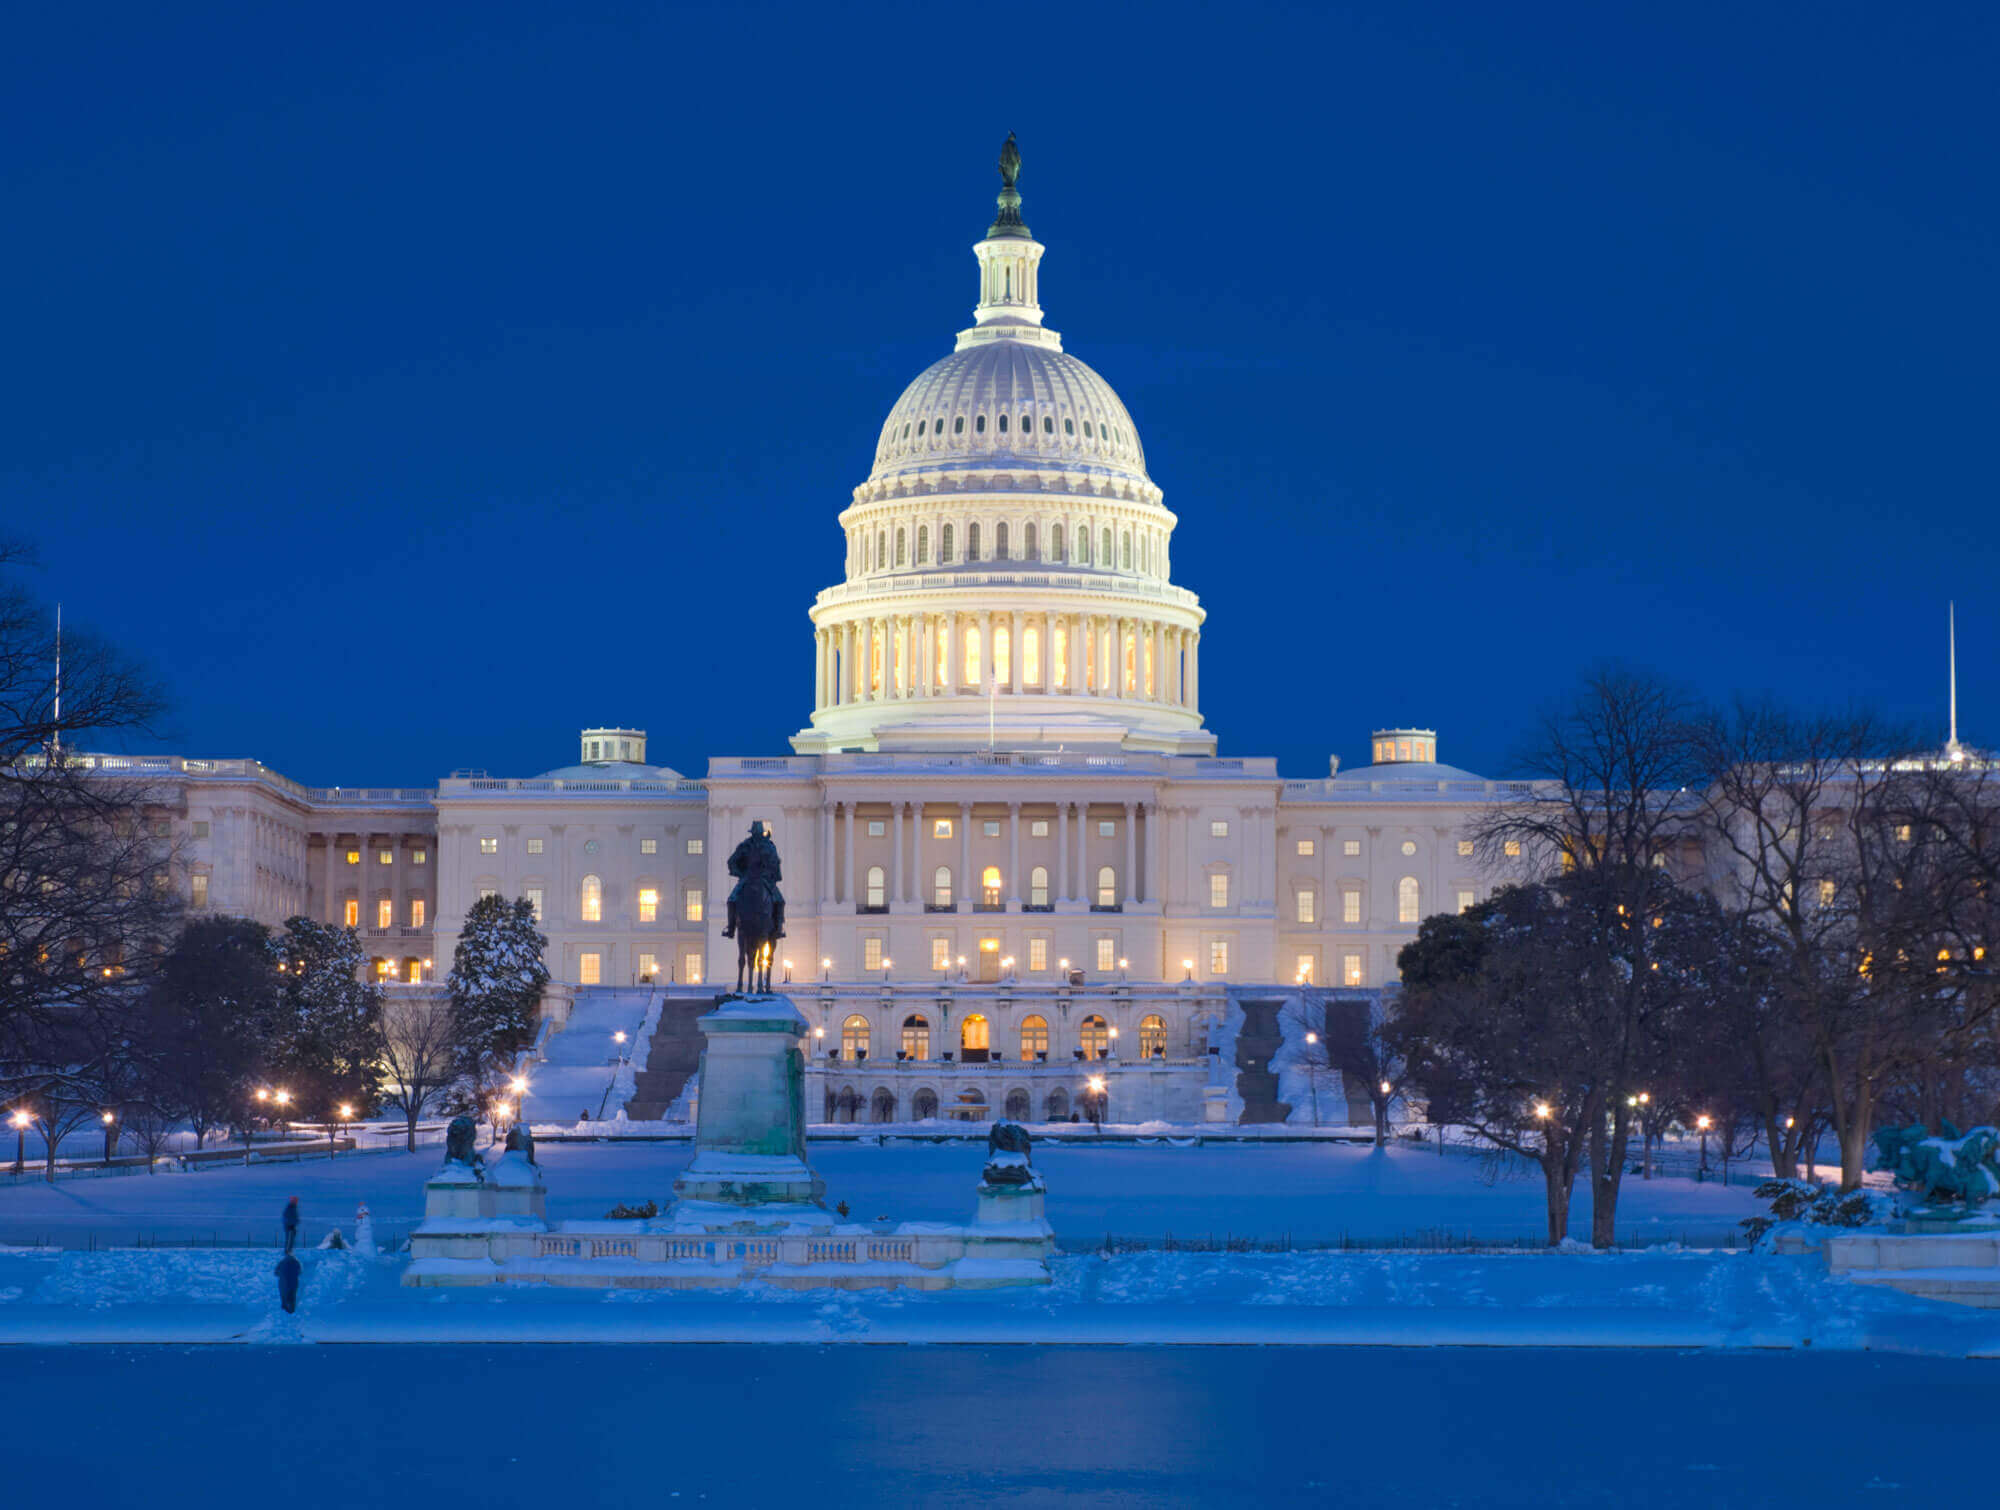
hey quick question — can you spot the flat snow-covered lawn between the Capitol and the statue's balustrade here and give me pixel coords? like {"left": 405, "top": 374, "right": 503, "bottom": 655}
{"left": 0, "top": 1142, "right": 1760, "bottom": 1248}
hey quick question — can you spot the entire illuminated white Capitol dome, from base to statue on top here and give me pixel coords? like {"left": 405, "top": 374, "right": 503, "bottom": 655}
{"left": 792, "top": 136, "right": 1216, "bottom": 754}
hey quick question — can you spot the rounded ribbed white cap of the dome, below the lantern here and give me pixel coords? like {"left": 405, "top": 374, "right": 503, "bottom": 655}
{"left": 868, "top": 340, "right": 1150, "bottom": 490}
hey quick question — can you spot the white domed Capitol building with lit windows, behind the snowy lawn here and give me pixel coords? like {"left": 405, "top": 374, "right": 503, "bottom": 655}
{"left": 96, "top": 142, "right": 1500, "bottom": 1122}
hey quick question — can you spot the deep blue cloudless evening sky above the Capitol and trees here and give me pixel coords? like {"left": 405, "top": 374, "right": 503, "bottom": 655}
{"left": 0, "top": 4, "right": 2000, "bottom": 784}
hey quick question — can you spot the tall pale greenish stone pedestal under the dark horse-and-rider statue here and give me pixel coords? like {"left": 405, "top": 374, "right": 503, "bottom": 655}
{"left": 674, "top": 994, "right": 826, "bottom": 1206}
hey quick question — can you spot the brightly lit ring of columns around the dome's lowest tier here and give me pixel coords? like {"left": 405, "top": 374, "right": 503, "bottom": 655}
{"left": 814, "top": 608, "right": 1202, "bottom": 712}
